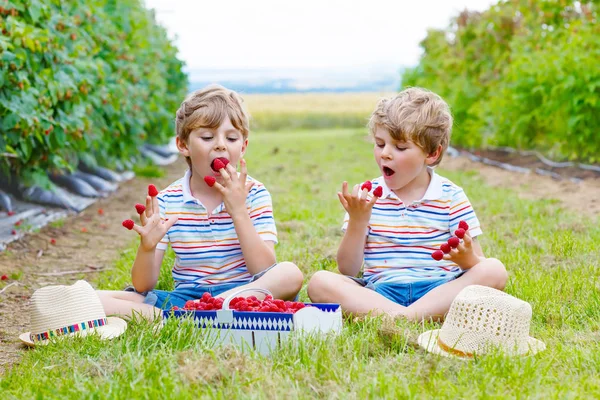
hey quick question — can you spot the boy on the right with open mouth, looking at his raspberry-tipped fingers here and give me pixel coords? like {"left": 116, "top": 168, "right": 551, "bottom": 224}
{"left": 308, "top": 88, "right": 507, "bottom": 320}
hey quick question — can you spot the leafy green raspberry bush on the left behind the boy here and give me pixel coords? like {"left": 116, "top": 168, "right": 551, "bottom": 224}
{"left": 0, "top": 0, "right": 187, "bottom": 187}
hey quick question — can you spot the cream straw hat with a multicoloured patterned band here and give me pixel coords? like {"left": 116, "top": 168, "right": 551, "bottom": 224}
{"left": 19, "top": 281, "right": 127, "bottom": 346}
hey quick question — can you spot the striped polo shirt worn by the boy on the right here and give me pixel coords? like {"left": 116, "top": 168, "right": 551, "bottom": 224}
{"left": 342, "top": 168, "right": 482, "bottom": 282}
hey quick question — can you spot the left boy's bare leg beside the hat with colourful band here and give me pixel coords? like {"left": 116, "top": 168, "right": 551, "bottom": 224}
{"left": 96, "top": 290, "right": 162, "bottom": 320}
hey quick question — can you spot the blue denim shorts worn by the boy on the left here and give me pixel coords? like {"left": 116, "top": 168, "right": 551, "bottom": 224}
{"left": 125, "top": 264, "right": 277, "bottom": 310}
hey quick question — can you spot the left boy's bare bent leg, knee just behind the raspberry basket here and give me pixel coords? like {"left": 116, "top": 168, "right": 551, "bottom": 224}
{"left": 219, "top": 262, "right": 304, "bottom": 300}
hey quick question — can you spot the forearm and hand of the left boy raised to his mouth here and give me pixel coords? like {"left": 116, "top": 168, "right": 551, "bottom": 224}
{"left": 215, "top": 159, "right": 276, "bottom": 275}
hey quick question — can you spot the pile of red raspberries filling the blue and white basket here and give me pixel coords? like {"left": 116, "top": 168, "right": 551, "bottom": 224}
{"left": 173, "top": 292, "right": 310, "bottom": 314}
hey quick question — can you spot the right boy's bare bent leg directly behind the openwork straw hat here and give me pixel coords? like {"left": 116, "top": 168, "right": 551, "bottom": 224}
{"left": 400, "top": 258, "right": 508, "bottom": 321}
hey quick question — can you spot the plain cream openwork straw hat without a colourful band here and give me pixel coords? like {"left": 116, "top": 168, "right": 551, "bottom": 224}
{"left": 418, "top": 285, "right": 546, "bottom": 358}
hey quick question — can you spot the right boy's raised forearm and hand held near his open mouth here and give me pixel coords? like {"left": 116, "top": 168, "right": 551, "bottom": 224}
{"left": 337, "top": 182, "right": 379, "bottom": 276}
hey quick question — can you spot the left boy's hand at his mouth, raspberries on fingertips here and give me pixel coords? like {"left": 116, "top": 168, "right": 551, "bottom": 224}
{"left": 214, "top": 159, "right": 254, "bottom": 217}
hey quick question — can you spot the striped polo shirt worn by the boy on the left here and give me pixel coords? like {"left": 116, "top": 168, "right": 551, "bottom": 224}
{"left": 156, "top": 170, "right": 277, "bottom": 289}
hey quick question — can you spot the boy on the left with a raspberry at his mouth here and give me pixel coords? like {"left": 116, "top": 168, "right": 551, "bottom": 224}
{"left": 99, "top": 85, "right": 303, "bottom": 318}
